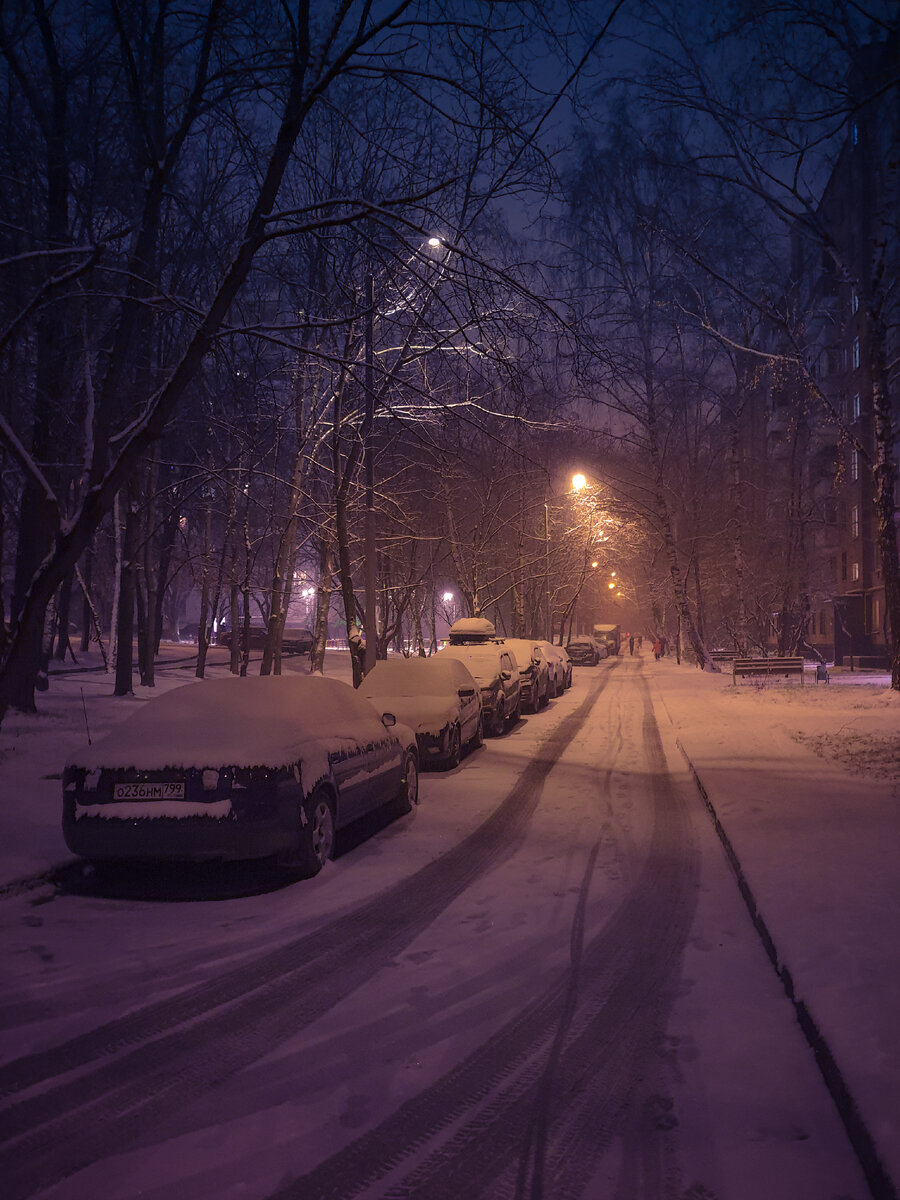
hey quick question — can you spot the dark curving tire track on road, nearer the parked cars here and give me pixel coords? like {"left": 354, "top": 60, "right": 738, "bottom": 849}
{"left": 0, "top": 672, "right": 611, "bottom": 1200}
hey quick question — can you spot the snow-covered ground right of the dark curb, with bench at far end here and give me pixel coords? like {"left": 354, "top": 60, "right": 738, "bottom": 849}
{"left": 644, "top": 656, "right": 900, "bottom": 1194}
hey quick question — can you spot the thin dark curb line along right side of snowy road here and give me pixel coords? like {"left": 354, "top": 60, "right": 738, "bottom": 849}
{"left": 676, "top": 737, "right": 898, "bottom": 1200}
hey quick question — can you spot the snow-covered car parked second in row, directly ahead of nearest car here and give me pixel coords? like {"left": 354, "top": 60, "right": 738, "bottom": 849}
{"left": 359, "top": 655, "right": 485, "bottom": 769}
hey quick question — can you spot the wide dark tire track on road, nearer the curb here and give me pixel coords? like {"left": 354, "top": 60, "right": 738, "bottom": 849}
{"left": 269, "top": 679, "right": 698, "bottom": 1200}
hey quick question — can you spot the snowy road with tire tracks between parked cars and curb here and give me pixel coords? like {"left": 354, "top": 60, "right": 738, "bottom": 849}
{"left": 0, "top": 658, "right": 868, "bottom": 1200}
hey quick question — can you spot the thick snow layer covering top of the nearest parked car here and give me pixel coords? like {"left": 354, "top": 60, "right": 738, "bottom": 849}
{"left": 70, "top": 674, "right": 384, "bottom": 770}
